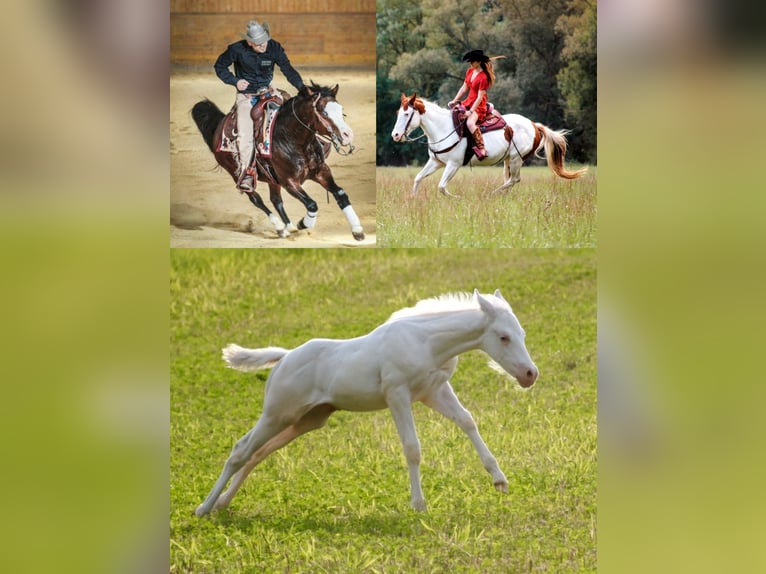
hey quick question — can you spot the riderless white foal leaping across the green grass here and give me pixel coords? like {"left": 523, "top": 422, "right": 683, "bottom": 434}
{"left": 196, "top": 291, "right": 538, "bottom": 516}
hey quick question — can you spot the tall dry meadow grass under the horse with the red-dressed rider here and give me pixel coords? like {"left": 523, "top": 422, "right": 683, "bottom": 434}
{"left": 377, "top": 163, "right": 596, "bottom": 248}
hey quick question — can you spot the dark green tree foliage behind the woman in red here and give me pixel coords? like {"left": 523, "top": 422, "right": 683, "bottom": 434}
{"left": 376, "top": 0, "right": 597, "bottom": 165}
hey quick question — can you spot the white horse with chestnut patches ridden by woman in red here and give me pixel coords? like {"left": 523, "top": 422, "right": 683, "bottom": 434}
{"left": 391, "top": 94, "right": 587, "bottom": 197}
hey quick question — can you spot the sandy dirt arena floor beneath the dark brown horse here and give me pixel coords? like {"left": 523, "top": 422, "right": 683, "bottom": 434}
{"left": 170, "top": 69, "right": 375, "bottom": 248}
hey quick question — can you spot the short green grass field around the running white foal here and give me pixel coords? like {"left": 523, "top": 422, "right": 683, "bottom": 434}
{"left": 170, "top": 250, "right": 597, "bottom": 574}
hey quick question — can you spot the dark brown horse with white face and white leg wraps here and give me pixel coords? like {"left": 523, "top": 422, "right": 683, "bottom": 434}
{"left": 191, "top": 83, "right": 364, "bottom": 241}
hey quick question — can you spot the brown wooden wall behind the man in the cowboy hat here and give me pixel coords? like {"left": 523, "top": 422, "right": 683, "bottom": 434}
{"left": 170, "top": 0, "right": 375, "bottom": 69}
